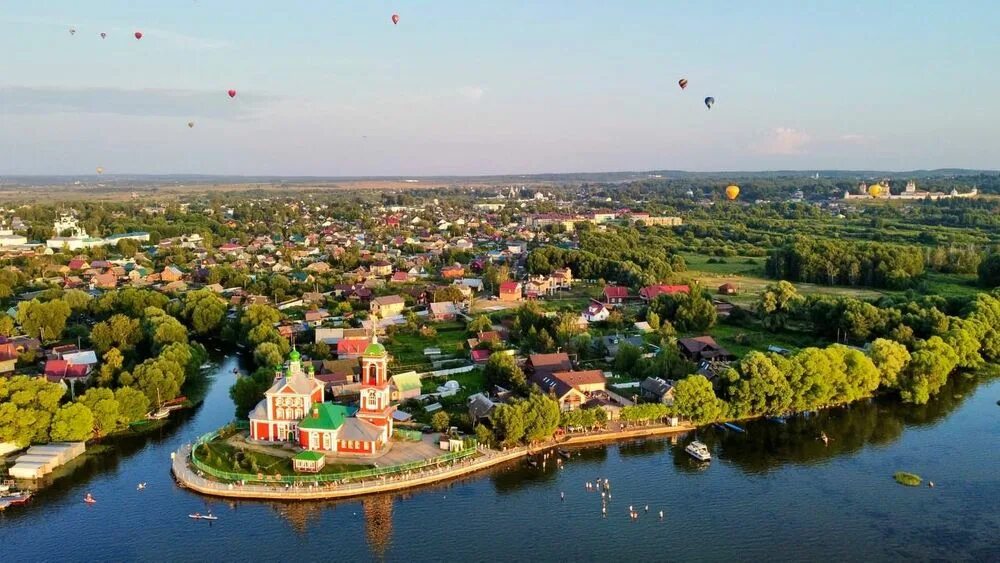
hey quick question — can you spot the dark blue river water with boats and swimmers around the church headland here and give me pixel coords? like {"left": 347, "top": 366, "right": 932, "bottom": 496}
{"left": 0, "top": 359, "right": 1000, "bottom": 562}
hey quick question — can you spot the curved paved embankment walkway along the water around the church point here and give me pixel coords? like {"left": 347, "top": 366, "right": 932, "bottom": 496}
{"left": 171, "top": 425, "right": 695, "bottom": 500}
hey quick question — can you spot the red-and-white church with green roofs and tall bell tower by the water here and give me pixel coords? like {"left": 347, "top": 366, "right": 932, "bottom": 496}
{"left": 250, "top": 338, "right": 395, "bottom": 455}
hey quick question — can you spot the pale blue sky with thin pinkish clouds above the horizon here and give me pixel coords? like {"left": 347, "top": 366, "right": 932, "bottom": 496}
{"left": 0, "top": 0, "right": 1000, "bottom": 176}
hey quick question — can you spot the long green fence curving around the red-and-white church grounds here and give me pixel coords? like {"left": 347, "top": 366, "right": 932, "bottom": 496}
{"left": 191, "top": 432, "right": 477, "bottom": 485}
